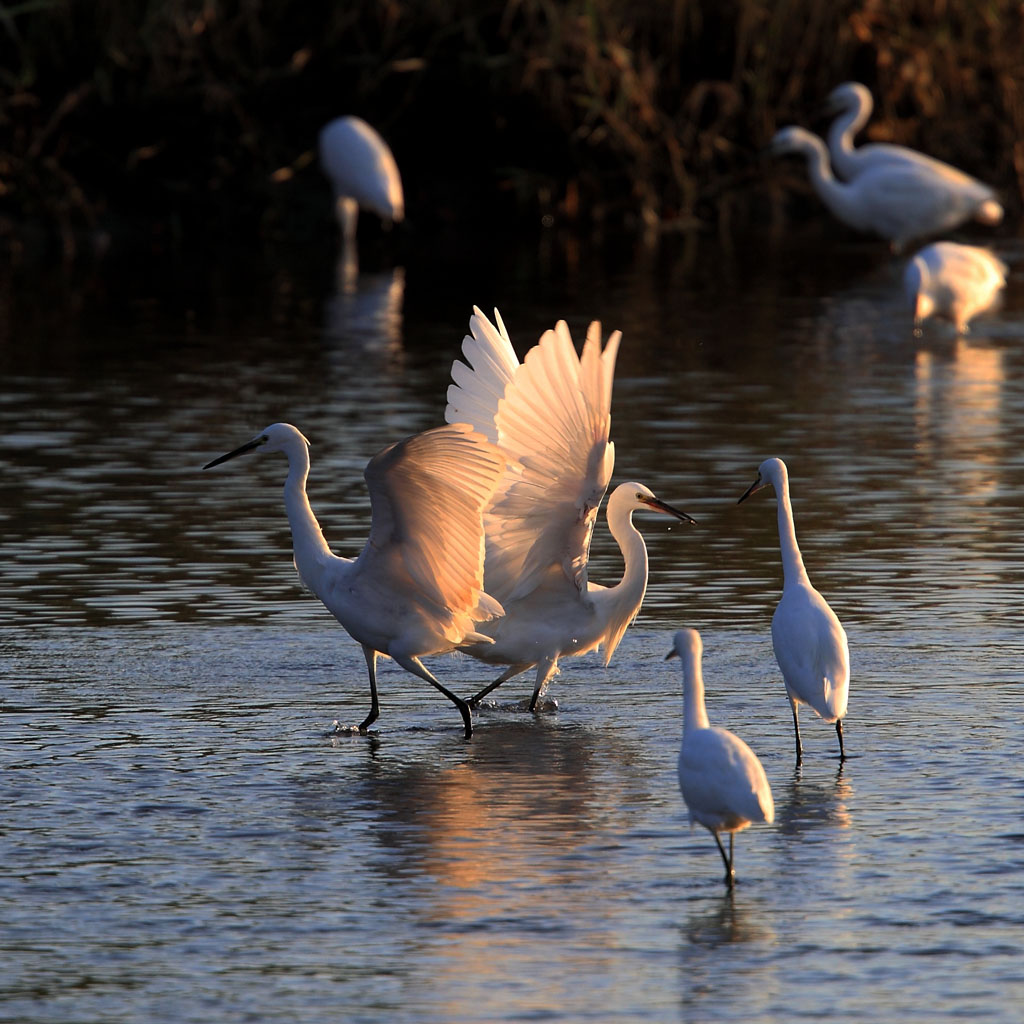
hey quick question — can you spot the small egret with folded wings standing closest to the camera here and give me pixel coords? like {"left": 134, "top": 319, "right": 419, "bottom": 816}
{"left": 668, "top": 630, "right": 775, "bottom": 888}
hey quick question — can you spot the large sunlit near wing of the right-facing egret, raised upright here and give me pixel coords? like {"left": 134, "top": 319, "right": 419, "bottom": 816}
{"left": 484, "top": 321, "right": 622, "bottom": 601}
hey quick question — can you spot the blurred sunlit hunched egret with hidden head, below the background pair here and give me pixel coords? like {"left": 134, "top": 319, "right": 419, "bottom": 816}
{"left": 903, "top": 242, "right": 1007, "bottom": 334}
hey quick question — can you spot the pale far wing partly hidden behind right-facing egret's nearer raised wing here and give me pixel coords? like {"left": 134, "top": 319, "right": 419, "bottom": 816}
{"left": 444, "top": 306, "right": 519, "bottom": 442}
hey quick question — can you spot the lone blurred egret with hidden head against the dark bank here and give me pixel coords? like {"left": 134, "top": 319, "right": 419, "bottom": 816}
{"left": 319, "top": 117, "right": 406, "bottom": 242}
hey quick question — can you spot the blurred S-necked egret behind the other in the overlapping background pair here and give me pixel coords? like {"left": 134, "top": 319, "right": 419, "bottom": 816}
{"left": 825, "top": 82, "right": 1002, "bottom": 224}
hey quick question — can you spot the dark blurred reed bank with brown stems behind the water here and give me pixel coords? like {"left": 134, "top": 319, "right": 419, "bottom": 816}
{"left": 0, "top": 0, "right": 1024, "bottom": 250}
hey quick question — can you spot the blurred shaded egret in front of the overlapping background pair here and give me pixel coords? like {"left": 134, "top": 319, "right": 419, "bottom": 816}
{"left": 771, "top": 127, "right": 984, "bottom": 251}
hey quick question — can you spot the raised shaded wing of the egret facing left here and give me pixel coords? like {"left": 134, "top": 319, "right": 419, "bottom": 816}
{"left": 359, "top": 423, "right": 505, "bottom": 643}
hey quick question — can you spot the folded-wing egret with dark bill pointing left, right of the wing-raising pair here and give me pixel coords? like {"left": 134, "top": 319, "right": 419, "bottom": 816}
{"left": 739, "top": 459, "right": 850, "bottom": 764}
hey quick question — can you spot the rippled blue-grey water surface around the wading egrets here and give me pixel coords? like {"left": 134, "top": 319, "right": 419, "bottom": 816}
{"left": 0, "top": 228, "right": 1024, "bottom": 1024}
